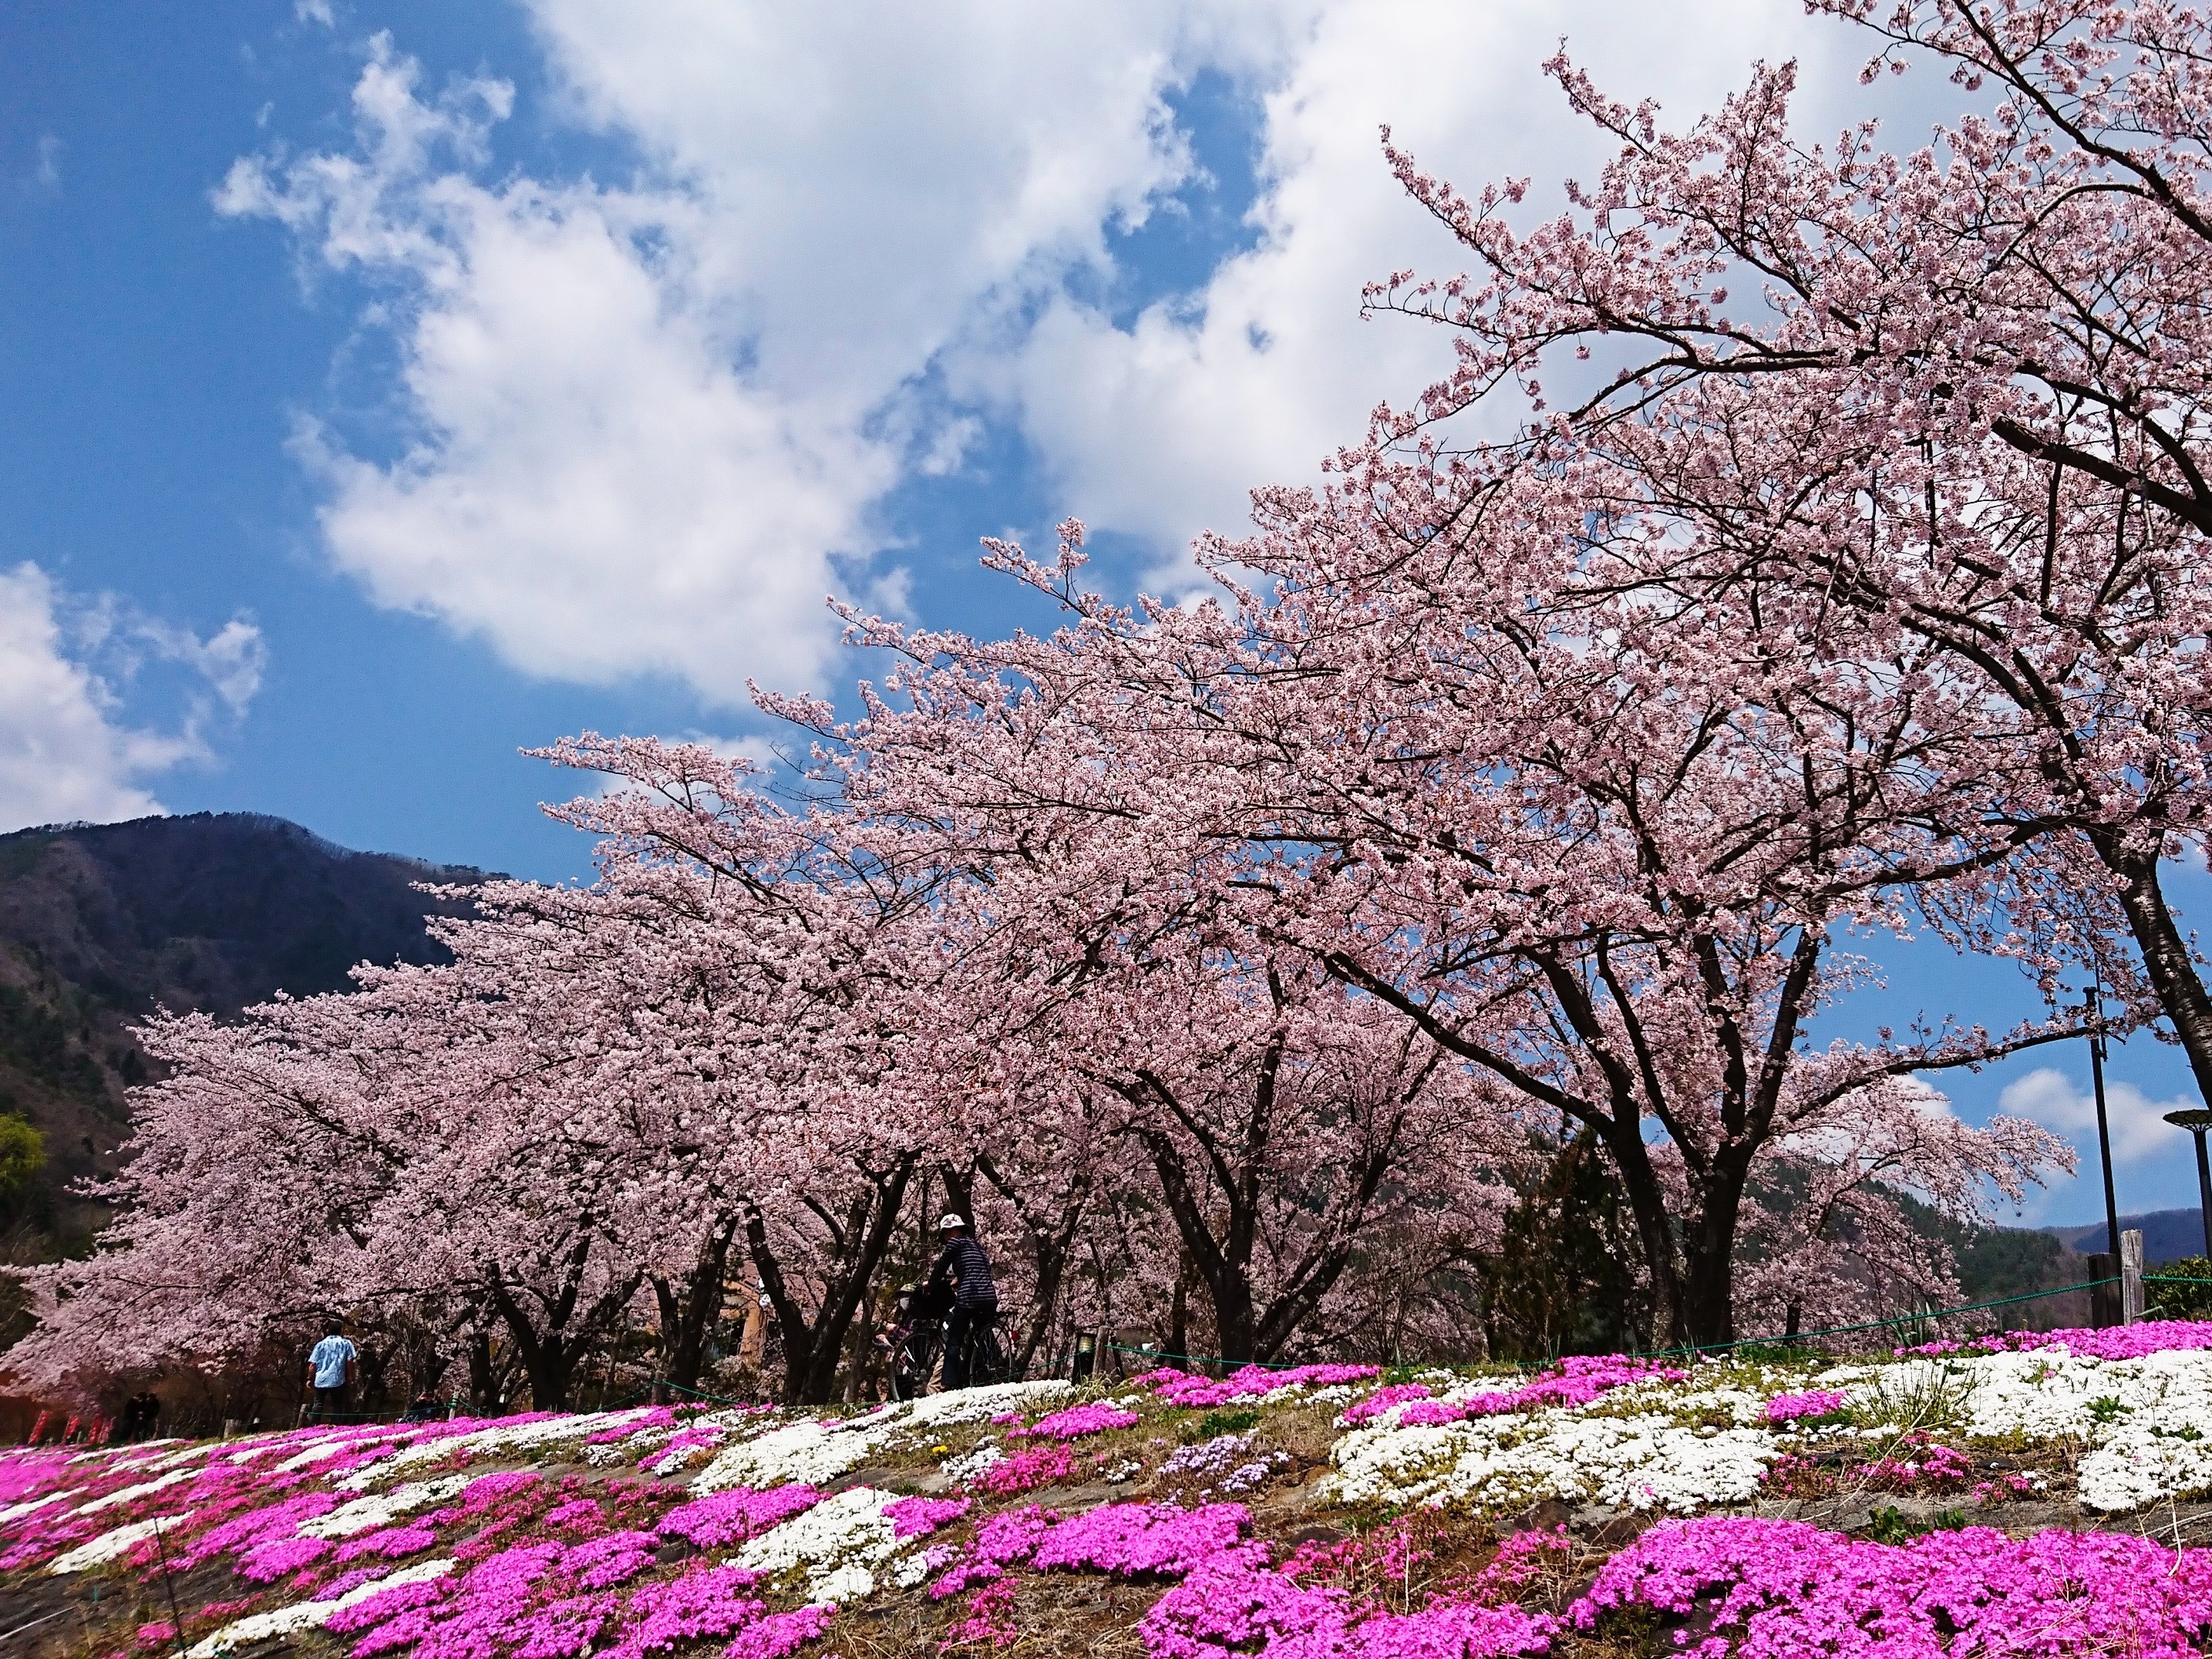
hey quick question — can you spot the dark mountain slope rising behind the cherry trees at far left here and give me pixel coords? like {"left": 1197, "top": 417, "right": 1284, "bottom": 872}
{"left": 0, "top": 812, "right": 484, "bottom": 1259}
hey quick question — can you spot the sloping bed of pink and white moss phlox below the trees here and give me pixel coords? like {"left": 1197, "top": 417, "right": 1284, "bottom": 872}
{"left": 12, "top": 1325, "right": 2212, "bottom": 1659}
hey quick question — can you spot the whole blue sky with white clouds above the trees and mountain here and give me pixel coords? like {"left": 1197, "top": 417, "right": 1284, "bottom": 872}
{"left": 0, "top": 0, "right": 2205, "bottom": 1219}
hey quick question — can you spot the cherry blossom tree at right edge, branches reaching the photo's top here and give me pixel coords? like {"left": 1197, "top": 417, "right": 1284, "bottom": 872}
{"left": 1369, "top": 0, "right": 2212, "bottom": 1105}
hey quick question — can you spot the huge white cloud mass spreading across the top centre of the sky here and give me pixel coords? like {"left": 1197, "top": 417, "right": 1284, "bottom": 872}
{"left": 217, "top": 0, "right": 1964, "bottom": 703}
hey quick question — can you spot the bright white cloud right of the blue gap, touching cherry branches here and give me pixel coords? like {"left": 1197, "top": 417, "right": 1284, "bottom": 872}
{"left": 962, "top": 0, "right": 1863, "bottom": 566}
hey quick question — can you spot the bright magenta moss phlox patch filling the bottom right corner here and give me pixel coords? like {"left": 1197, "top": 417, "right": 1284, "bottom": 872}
{"left": 1571, "top": 1517, "right": 2212, "bottom": 1659}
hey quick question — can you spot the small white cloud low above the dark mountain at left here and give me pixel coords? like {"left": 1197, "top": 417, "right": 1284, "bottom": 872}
{"left": 0, "top": 564, "right": 263, "bottom": 830}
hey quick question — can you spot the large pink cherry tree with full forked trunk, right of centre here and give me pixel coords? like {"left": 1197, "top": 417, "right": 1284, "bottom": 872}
{"left": 844, "top": 504, "right": 2077, "bottom": 1343}
